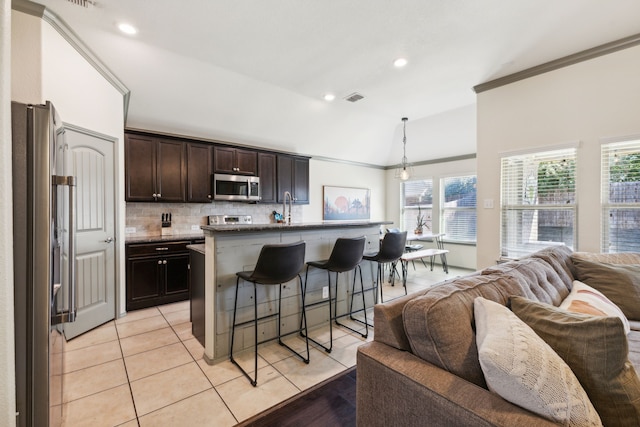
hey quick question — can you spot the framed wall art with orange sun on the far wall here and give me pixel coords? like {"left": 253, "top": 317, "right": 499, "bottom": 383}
{"left": 322, "top": 185, "right": 371, "bottom": 221}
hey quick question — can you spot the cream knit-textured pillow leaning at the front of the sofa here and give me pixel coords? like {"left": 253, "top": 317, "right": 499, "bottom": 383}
{"left": 473, "top": 297, "right": 602, "bottom": 426}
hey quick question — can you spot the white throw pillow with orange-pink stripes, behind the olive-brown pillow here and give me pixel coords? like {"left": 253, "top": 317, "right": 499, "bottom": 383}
{"left": 560, "top": 280, "right": 631, "bottom": 334}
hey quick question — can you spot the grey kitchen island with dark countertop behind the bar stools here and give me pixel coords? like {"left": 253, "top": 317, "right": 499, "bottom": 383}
{"left": 201, "top": 221, "right": 391, "bottom": 364}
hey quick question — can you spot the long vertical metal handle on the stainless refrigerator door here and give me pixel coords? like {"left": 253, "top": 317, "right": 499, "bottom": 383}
{"left": 51, "top": 176, "right": 76, "bottom": 325}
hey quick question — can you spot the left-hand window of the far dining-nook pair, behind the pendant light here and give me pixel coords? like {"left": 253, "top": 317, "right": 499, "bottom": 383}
{"left": 401, "top": 179, "right": 433, "bottom": 232}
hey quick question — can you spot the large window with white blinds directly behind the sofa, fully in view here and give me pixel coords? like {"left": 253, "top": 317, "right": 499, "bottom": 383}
{"left": 500, "top": 148, "right": 577, "bottom": 258}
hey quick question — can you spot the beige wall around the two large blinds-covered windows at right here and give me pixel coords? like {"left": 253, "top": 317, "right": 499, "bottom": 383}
{"left": 477, "top": 46, "right": 640, "bottom": 268}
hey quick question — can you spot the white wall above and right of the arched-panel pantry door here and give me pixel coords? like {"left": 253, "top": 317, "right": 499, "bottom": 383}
{"left": 11, "top": 10, "right": 125, "bottom": 314}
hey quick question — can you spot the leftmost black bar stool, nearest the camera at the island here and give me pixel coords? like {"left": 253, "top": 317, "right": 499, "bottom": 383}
{"left": 230, "top": 242, "right": 309, "bottom": 387}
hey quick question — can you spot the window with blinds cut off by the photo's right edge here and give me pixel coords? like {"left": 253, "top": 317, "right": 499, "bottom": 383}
{"left": 601, "top": 140, "right": 640, "bottom": 253}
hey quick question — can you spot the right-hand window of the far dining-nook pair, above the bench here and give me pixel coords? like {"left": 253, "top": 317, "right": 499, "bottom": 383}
{"left": 440, "top": 175, "right": 477, "bottom": 243}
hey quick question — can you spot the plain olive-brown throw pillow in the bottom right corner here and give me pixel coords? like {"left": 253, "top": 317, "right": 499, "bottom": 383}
{"left": 511, "top": 297, "right": 640, "bottom": 426}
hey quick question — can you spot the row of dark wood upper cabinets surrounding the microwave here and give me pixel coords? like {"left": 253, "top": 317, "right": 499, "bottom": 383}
{"left": 124, "top": 131, "right": 309, "bottom": 204}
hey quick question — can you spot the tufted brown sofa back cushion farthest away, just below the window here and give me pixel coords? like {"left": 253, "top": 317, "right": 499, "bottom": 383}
{"left": 482, "top": 256, "right": 572, "bottom": 305}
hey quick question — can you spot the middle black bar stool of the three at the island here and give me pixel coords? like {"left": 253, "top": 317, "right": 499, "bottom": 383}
{"left": 301, "top": 236, "right": 369, "bottom": 353}
